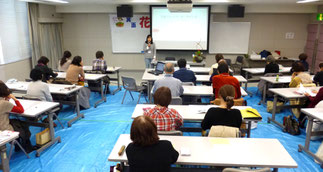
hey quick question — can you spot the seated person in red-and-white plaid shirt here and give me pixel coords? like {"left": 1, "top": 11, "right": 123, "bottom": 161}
{"left": 144, "top": 87, "right": 183, "bottom": 131}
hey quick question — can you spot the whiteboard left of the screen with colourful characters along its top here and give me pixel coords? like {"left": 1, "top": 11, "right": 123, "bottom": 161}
{"left": 110, "top": 14, "right": 150, "bottom": 53}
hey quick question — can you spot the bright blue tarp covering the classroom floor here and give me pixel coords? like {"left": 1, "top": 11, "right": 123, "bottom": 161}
{"left": 5, "top": 87, "right": 322, "bottom": 172}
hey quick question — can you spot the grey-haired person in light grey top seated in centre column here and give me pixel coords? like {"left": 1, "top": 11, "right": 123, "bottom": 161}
{"left": 153, "top": 63, "right": 184, "bottom": 97}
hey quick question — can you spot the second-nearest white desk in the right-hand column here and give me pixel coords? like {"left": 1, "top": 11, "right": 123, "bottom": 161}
{"left": 268, "top": 87, "right": 320, "bottom": 129}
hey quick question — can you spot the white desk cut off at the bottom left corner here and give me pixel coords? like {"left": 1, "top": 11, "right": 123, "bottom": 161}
{"left": 0, "top": 131, "right": 19, "bottom": 172}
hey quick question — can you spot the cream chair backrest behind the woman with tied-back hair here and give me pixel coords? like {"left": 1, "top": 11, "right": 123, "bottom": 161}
{"left": 208, "top": 125, "right": 241, "bottom": 138}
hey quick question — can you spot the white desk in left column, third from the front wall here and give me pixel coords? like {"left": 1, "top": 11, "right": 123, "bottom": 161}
{"left": 6, "top": 81, "right": 84, "bottom": 127}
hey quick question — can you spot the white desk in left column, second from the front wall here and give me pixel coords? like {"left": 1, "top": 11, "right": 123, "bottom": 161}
{"left": 57, "top": 72, "right": 107, "bottom": 108}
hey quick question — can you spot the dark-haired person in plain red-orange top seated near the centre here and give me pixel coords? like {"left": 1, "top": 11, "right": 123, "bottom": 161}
{"left": 212, "top": 63, "right": 241, "bottom": 99}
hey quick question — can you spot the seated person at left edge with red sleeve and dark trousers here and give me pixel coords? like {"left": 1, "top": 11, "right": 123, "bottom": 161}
{"left": 0, "top": 82, "right": 33, "bottom": 153}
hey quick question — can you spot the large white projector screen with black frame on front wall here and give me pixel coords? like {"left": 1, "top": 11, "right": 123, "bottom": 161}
{"left": 150, "top": 6, "right": 209, "bottom": 50}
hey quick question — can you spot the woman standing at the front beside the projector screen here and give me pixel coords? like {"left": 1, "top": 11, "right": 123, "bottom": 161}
{"left": 143, "top": 35, "right": 156, "bottom": 68}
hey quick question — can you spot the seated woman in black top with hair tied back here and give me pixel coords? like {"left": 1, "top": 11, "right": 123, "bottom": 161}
{"left": 201, "top": 85, "right": 242, "bottom": 130}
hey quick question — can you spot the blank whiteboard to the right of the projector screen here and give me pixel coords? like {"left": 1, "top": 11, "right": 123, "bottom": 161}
{"left": 209, "top": 22, "right": 251, "bottom": 54}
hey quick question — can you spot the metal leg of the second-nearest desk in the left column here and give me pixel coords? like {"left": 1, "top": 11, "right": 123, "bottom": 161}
{"left": 36, "top": 112, "right": 61, "bottom": 157}
